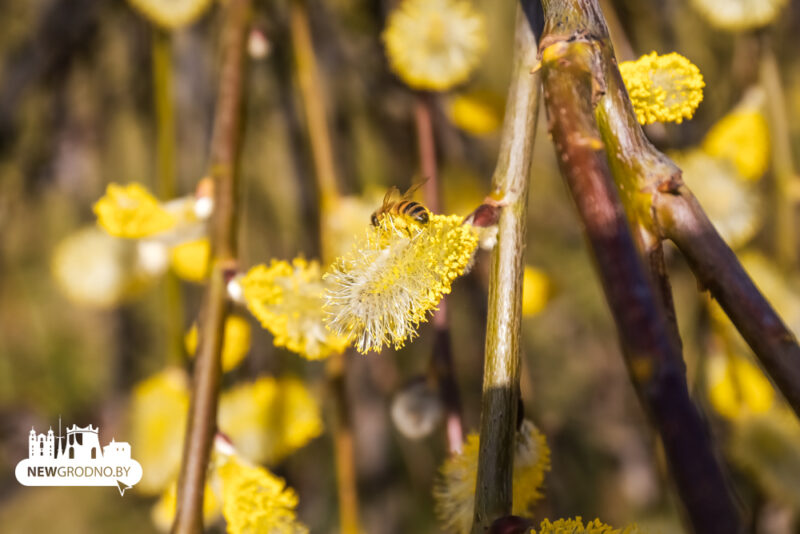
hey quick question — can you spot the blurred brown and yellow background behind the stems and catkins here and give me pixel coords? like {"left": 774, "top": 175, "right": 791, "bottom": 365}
{"left": 0, "top": 0, "right": 800, "bottom": 534}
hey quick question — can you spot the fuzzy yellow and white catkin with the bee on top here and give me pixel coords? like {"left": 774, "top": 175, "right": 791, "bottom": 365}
{"left": 325, "top": 214, "right": 478, "bottom": 353}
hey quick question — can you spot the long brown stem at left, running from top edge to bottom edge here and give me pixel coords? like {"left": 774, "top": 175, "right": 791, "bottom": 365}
{"left": 172, "top": 0, "right": 250, "bottom": 534}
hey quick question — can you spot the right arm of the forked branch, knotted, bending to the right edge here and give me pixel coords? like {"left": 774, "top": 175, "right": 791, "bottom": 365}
{"left": 563, "top": 0, "right": 800, "bottom": 422}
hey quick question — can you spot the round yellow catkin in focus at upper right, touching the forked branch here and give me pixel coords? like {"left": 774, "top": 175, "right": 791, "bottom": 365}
{"left": 619, "top": 52, "right": 705, "bottom": 124}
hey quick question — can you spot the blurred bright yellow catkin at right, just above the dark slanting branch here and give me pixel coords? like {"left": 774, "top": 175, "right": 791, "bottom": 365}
{"left": 703, "top": 110, "right": 770, "bottom": 180}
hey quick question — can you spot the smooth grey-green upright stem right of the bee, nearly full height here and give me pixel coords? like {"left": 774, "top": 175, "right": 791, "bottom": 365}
{"left": 472, "top": 2, "right": 541, "bottom": 533}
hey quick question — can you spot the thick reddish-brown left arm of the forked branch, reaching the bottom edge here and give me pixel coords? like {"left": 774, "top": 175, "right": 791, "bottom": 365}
{"left": 541, "top": 0, "right": 743, "bottom": 534}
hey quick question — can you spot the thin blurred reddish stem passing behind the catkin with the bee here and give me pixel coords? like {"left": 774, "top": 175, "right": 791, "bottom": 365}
{"left": 414, "top": 93, "right": 464, "bottom": 454}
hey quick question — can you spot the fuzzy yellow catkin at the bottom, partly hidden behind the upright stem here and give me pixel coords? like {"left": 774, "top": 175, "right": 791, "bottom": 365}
{"left": 433, "top": 420, "right": 550, "bottom": 534}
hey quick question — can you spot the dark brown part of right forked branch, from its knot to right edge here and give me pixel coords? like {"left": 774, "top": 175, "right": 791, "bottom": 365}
{"left": 656, "top": 191, "right": 800, "bottom": 416}
